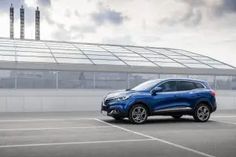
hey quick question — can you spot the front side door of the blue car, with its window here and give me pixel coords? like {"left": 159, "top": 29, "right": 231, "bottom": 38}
{"left": 152, "top": 81, "right": 177, "bottom": 112}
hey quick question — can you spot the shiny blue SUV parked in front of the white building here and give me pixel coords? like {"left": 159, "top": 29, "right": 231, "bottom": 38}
{"left": 101, "top": 79, "right": 216, "bottom": 124}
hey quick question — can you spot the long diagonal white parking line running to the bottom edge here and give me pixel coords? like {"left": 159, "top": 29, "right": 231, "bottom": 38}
{"left": 95, "top": 118, "right": 215, "bottom": 157}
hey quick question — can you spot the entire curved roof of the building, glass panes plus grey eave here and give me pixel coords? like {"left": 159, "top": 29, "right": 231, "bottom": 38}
{"left": 0, "top": 38, "right": 235, "bottom": 74}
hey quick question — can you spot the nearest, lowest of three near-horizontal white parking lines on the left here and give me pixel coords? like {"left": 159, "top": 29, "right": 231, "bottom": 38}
{"left": 0, "top": 139, "right": 153, "bottom": 148}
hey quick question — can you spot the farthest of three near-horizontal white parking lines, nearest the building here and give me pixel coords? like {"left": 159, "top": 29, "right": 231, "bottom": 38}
{"left": 0, "top": 118, "right": 94, "bottom": 123}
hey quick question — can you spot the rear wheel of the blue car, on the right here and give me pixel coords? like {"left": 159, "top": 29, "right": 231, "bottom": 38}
{"left": 193, "top": 103, "right": 211, "bottom": 122}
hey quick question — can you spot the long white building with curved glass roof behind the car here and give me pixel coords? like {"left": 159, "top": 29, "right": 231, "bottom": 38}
{"left": 0, "top": 38, "right": 236, "bottom": 112}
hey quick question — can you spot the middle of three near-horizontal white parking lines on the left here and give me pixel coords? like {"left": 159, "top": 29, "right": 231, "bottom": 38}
{"left": 0, "top": 126, "right": 111, "bottom": 132}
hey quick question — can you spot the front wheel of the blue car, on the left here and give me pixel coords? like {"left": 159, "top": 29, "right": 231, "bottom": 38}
{"left": 129, "top": 104, "right": 148, "bottom": 124}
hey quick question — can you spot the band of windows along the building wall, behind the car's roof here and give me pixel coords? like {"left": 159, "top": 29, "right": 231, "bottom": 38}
{"left": 0, "top": 70, "right": 236, "bottom": 90}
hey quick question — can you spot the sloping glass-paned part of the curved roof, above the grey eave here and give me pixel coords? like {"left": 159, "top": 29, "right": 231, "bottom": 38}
{"left": 0, "top": 38, "right": 234, "bottom": 69}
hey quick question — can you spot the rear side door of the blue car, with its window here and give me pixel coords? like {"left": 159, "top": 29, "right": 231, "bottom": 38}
{"left": 176, "top": 81, "right": 198, "bottom": 108}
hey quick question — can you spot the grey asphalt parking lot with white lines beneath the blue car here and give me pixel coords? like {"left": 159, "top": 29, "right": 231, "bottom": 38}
{"left": 0, "top": 110, "right": 236, "bottom": 157}
